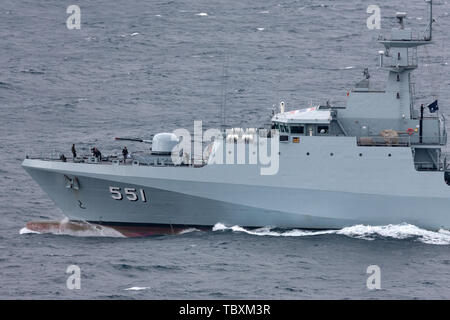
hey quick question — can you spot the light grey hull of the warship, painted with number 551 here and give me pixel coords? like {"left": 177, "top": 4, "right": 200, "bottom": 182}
{"left": 22, "top": 137, "right": 450, "bottom": 230}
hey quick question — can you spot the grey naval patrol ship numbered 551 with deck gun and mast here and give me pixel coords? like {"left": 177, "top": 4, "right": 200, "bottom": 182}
{"left": 22, "top": 0, "right": 450, "bottom": 236}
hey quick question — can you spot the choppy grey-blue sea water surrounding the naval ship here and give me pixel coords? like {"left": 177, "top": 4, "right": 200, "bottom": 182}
{"left": 0, "top": 0, "right": 450, "bottom": 299}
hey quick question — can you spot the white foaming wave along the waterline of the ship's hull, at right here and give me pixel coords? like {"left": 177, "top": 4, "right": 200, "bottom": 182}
{"left": 213, "top": 223, "right": 450, "bottom": 245}
